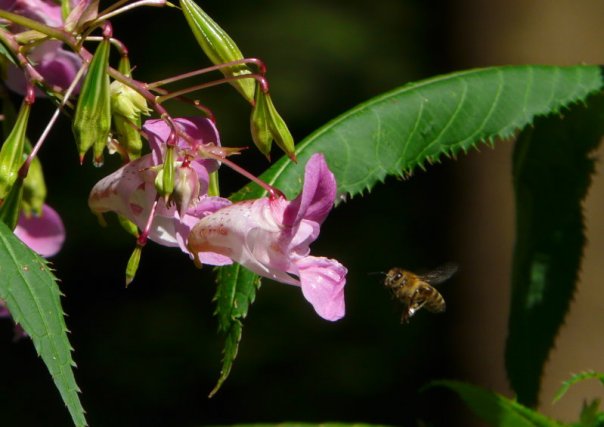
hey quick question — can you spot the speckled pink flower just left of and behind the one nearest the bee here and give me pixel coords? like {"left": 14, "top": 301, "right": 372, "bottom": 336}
{"left": 88, "top": 117, "right": 232, "bottom": 265}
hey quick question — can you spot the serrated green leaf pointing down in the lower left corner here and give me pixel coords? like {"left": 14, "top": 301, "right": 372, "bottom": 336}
{"left": 0, "top": 223, "right": 87, "bottom": 427}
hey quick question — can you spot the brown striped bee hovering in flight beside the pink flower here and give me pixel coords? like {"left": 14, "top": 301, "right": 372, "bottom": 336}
{"left": 384, "top": 263, "right": 458, "bottom": 323}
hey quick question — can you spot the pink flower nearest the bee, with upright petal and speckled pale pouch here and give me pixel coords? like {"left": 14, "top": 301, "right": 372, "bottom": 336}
{"left": 188, "top": 154, "right": 347, "bottom": 320}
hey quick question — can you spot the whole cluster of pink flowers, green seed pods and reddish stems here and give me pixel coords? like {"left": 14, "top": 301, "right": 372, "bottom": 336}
{"left": 0, "top": 0, "right": 347, "bottom": 320}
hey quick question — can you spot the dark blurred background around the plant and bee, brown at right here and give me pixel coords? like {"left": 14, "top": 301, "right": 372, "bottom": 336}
{"left": 0, "top": 0, "right": 604, "bottom": 427}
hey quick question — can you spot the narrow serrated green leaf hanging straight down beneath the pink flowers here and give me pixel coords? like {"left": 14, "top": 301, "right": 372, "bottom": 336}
{"left": 210, "top": 264, "right": 260, "bottom": 397}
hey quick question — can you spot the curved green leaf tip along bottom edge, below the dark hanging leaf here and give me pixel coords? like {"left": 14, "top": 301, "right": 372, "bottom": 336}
{"left": 428, "top": 381, "right": 564, "bottom": 427}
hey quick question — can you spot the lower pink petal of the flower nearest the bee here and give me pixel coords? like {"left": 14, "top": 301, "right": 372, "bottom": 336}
{"left": 295, "top": 256, "right": 348, "bottom": 321}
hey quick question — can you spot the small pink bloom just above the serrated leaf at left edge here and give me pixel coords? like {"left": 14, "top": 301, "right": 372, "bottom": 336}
{"left": 14, "top": 205, "right": 65, "bottom": 257}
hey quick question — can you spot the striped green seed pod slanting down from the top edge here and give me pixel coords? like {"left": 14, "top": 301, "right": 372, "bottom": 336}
{"left": 180, "top": 0, "right": 256, "bottom": 104}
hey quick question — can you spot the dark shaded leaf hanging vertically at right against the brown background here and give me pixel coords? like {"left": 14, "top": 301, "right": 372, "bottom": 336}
{"left": 506, "top": 96, "right": 604, "bottom": 406}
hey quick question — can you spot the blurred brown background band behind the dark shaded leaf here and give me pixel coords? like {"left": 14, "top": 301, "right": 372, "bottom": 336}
{"left": 451, "top": 0, "right": 604, "bottom": 422}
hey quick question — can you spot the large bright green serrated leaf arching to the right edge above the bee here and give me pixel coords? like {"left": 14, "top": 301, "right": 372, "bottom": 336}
{"left": 217, "top": 66, "right": 602, "bottom": 394}
